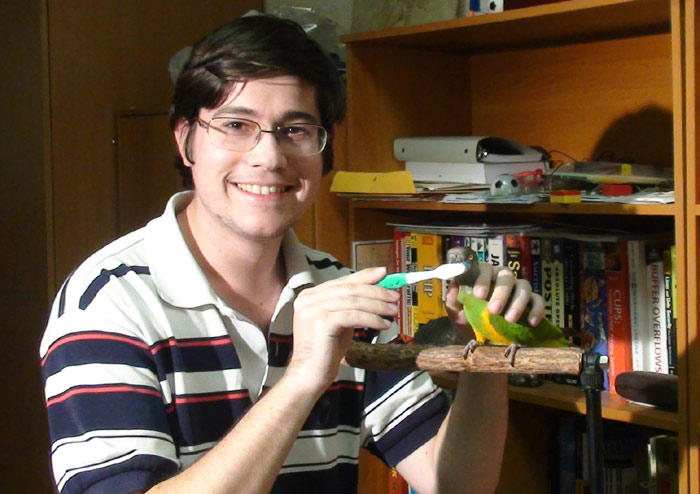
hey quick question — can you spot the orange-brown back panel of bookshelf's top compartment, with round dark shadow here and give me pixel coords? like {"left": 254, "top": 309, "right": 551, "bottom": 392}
{"left": 471, "top": 34, "right": 673, "bottom": 167}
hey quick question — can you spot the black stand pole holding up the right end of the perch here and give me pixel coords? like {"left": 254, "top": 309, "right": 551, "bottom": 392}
{"left": 581, "top": 353, "right": 607, "bottom": 494}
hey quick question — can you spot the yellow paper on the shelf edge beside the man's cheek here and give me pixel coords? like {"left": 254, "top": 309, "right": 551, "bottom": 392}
{"left": 331, "top": 170, "right": 416, "bottom": 194}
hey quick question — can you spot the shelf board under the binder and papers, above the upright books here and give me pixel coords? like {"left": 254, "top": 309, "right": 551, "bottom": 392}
{"left": 351, "top": 198, "right": 682, "bottom": 216}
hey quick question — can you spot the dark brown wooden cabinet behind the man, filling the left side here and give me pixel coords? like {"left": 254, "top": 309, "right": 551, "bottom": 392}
{"left": 0, "top": 0, "right": 263, "bottom": 493}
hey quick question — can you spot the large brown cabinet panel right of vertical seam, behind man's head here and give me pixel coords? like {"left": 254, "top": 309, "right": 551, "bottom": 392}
{"left": 48, "top": 0, "right": 262, "bottom": 283}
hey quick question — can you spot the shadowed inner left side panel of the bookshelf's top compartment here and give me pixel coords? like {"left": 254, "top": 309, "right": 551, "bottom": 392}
{"left": 348, "top": 43, "right": 471, "bottom": 171}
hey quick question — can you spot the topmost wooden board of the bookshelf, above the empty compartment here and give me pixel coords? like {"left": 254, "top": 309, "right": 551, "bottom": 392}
{"left": 340, "top": 0, "right": 671, "bottom": 52}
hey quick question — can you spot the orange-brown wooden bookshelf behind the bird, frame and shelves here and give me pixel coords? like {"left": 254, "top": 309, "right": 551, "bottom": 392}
{"left": 335, "top": 0, "right": 700, "bottom": 494}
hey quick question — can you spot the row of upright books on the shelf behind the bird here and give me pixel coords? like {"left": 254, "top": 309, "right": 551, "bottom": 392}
{"left": 391, "top": 224, "right": 677, "bottom": 391}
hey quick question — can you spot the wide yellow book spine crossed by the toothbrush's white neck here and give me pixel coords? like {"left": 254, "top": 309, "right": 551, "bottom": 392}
{"left": 414, "top": 233, "right": 447, "bottom": 328}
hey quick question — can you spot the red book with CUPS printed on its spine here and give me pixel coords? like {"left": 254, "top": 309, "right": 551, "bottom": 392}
{"left": 605, "top": 241, "right": 632, "bottom": 393}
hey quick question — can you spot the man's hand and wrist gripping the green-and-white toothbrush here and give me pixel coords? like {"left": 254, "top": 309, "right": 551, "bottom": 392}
{"left": 287, "top": 268, "right": 400, "bottom": 392}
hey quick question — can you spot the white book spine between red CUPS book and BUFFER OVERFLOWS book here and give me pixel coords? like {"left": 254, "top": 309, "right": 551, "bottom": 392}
{"left": 627, "top": 240, "right": 651, "bottom": 371}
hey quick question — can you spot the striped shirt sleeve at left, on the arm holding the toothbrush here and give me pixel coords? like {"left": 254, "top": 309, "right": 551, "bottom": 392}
{"left": 41, "top": 310, "right": 181, "bottom": 494}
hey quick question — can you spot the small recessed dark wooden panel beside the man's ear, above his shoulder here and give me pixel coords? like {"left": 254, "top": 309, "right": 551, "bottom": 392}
{"left": 117, "top": 114, "right": 182, "bottom": 234}
